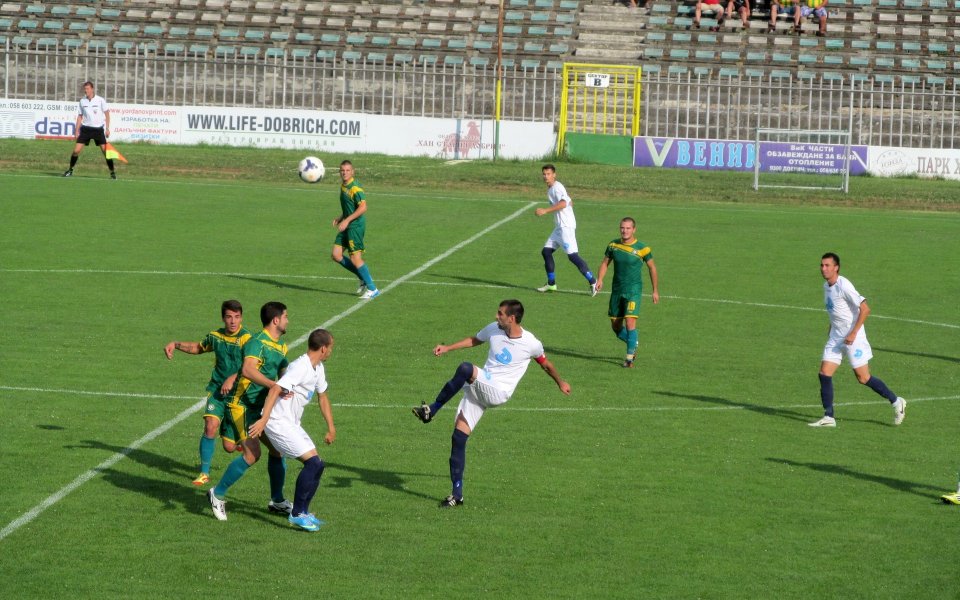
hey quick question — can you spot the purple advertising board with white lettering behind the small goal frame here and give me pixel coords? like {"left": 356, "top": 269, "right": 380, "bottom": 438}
{"left": 633, "top": 136, "right": 867, "bottom": 175}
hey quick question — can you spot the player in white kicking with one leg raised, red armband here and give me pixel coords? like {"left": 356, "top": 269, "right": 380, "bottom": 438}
{"left": 413, "top": 300, "right": 570, "bottom": 508}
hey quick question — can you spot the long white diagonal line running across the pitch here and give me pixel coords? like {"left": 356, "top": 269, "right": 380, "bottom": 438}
{"left": 0, "top": 202, "right": 536, "bottom": 541}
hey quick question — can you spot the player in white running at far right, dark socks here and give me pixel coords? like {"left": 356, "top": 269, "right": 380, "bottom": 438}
{"left": 810, "top": 252, "right": 907, "bottom": 427}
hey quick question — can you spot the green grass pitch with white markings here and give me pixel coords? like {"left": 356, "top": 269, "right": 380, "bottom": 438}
{"left": 0, "top": 140, "right": 960, "bottom": 599}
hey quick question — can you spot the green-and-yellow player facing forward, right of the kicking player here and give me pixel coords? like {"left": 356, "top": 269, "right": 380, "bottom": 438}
{"left": 594, "top": 217, "right": 660, "bottom": 368}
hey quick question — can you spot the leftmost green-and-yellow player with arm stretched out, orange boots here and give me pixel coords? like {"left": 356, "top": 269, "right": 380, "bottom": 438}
{"left": 163, "top": 300, "right": 250, "bottom": 486}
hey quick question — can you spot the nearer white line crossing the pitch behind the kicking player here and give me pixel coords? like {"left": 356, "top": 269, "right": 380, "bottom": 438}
{"left": 0, "top": 385, "right": 960, "bottom": 412}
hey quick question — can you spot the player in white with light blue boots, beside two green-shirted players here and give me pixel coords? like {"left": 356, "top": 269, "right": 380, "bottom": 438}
{"left": 250, "top": 329, "right": 337, "bottom": 531}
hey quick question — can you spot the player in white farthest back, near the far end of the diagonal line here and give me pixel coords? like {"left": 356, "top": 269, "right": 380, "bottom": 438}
{"left": 536, "top": 165, "right": 597, "bottom": 296}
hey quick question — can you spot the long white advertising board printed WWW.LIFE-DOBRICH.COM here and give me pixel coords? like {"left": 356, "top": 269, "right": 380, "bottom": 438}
{"left": 0, "top": 99, "right": 555, "bottom": 159}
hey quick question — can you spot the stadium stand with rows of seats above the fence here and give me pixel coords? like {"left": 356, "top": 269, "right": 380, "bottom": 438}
{"left": 0, "top": 0, "right": 960, "bottom": 83}
